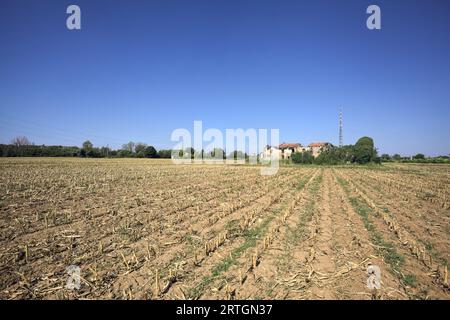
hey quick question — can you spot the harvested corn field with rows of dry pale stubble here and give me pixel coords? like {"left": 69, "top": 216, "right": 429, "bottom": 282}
{"left": 0, "top": 158, "right": 450, "bottom": 299}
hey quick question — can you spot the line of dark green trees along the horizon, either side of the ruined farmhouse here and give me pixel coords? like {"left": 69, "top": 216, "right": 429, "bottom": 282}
{"left": 0, "top": 137, "right": 450, "bottom": 165}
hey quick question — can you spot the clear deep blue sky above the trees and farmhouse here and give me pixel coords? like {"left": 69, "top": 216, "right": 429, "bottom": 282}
{"left": 0, "top": 0, "right": 450, "bottom": 155}
